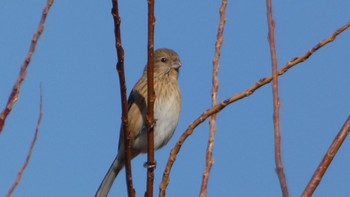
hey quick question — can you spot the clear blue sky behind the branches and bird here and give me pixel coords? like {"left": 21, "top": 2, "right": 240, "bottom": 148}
{"left": 0, "top": 0, "right": 350, "bottom": 197}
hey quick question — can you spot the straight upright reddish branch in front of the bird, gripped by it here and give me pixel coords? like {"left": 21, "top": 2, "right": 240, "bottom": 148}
{"left": 145, "top": 0, "right": 156, "bottom": 197}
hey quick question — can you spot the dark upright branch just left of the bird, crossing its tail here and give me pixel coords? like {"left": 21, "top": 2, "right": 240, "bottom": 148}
{"left": 112, "top": 0, "right": 135, "bottom": 197}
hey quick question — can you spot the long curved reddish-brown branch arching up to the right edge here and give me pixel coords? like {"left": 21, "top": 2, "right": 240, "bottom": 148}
{"left": 159, "top": 23, "right": 350, "bottom": 196}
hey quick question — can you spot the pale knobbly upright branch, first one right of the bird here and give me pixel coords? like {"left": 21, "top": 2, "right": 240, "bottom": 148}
{"left": 200, "top": 0, "right": 227, "bottom": 197}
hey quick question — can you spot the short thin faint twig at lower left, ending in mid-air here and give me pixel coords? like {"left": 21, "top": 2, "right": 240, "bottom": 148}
{"left": 6, "top": 88, "right": 43, "bottom": 197}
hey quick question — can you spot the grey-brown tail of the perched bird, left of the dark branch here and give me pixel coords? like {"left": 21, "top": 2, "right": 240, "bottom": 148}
{"left": 95, "top": 157, "right": 123, "bottom": 197}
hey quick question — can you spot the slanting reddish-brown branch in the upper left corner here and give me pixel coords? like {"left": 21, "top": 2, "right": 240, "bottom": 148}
{"left": 0, "top": 0, "right": 54, "bottom": 133}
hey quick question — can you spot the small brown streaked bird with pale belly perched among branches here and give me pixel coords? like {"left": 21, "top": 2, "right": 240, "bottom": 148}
{"left": 95, "top": 48, "right": 181, "bottom": 197}
